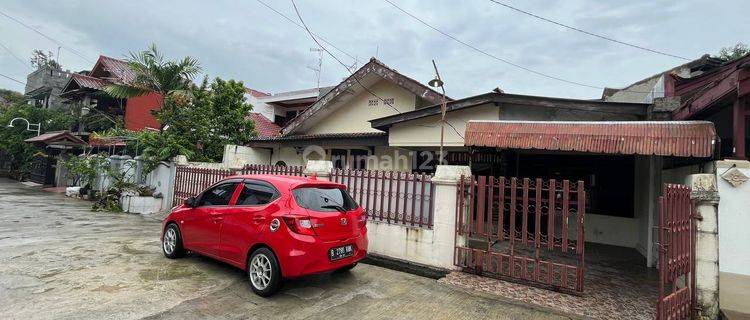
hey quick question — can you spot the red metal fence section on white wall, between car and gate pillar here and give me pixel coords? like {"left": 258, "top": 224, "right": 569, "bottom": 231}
{"left": 331, "top": 169, "right": 435, "bottom": 228}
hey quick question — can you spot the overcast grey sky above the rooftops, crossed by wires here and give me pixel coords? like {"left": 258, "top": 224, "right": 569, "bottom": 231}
{"left": 0, "top": 0, "right": 750, "bottom": 98}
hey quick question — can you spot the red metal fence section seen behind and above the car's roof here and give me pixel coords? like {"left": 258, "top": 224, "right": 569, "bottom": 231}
{"left": 172, "top": 164, "right": 304, "bottom": 205}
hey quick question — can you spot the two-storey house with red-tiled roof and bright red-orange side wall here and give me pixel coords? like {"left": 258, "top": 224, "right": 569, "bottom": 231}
{"left": 60, "top": 56, "right": 161, "bottom": 131}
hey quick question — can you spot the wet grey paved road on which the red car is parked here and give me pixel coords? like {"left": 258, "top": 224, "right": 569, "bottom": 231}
{"left": 0, "top": 178, "right": 559, "bottom": 320}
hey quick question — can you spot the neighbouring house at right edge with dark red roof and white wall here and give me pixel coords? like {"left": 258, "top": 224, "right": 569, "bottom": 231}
{"left": 604, "top": 55, "right": 750, "bottom": 314}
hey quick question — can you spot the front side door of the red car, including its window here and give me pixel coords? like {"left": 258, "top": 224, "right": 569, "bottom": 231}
{"left": 182, "top": 180, "right": 239, "bottom": 255}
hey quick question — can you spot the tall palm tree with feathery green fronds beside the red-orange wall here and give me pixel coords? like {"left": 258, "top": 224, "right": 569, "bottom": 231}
{"left": 104, "top": 44, "right": 201, "bottom": 128}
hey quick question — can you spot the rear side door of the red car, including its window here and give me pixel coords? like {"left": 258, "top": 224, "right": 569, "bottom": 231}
{"left": 219, "top": 179, "right": 280, "bottom": 265}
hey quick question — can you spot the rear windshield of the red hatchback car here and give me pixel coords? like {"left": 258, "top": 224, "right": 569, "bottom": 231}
{"left": 292, "top": 187, "right": 357, "bottom": 211}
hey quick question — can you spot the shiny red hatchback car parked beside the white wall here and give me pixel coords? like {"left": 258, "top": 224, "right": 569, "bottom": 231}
{"left": 162, "top": 175, "right": 367, "bottom": 297}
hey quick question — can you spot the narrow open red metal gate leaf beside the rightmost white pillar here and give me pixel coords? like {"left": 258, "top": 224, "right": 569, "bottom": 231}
{"left": 656, "top": 184, "right": 696, "bottom": 320}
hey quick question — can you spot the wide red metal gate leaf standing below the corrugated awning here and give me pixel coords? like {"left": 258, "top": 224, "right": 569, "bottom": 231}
{"left": 454, "top": 176, "right": 586, "bottom": 293}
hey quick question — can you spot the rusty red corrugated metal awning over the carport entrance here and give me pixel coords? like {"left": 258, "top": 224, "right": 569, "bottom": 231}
{"left": 464, "top": 121, "right": 716, "bottom": 158}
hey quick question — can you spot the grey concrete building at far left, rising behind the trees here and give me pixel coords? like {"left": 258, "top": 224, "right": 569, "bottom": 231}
{"left": 24, "top": 66, "right": 71, "bottom": 109}
